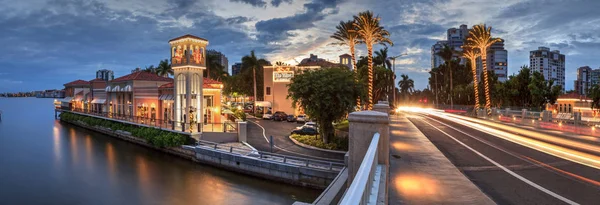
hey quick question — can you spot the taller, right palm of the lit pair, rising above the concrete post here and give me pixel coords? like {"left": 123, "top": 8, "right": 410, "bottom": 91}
{"left": 354, "top": 11, "right": 394, "bottom": 110}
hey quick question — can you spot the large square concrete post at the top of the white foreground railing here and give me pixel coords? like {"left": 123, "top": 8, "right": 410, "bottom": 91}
{"left": 348, "top": 111, "right": 390, "bottom": 182}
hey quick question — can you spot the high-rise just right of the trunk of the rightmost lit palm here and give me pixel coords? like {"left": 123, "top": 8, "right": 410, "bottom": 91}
{"left": 477, "top": 39, "right": 508, "bottom": 82}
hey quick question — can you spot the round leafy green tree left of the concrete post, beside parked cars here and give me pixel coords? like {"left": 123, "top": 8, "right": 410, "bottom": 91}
{"left": 287, "top": 68, "right": 364, "bottom": 143}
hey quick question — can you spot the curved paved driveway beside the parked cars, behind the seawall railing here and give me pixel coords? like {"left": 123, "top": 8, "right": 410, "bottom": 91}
{"left": 247, "top": 117, "right": 344, "bottom": 162}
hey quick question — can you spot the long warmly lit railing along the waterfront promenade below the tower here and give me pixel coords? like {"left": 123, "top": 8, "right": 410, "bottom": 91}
{"left": 62, "top": 108, "right": 237, "bottom": 133}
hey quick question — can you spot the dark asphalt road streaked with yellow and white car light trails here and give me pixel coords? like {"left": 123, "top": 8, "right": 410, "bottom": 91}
{"left": 407, "top": 113, "right": 600, "bottom": 204}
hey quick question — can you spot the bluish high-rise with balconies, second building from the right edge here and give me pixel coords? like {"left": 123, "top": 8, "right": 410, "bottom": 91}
{"left": 529, "top": 47, "right": 565, "bottom": 91}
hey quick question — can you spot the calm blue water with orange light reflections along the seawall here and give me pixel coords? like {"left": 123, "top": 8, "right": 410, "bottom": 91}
{"left": 0, "top": 98, "right": 319, "bottom": 205}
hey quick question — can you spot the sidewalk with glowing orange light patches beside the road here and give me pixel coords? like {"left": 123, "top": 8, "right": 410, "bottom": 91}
{"left": 388, "top": 116, "right": 495, "bottom": 205}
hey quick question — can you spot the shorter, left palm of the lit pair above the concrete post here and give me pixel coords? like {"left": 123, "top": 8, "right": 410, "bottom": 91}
{"left": 331, "top": 20, "right": 361, "bottom": 109}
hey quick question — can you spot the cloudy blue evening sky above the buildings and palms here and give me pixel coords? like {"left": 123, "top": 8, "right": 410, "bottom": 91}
{"left": 0, "top": 0, "right": 600, "bottom": 92}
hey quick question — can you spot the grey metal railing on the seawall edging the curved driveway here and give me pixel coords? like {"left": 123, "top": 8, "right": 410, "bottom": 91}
{"left": 198, "top": 140, "right": 345, "bottom": 171}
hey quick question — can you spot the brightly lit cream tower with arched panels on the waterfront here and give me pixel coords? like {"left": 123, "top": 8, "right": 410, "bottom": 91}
{"left": 169, "top": 34, "right": 208, "bottom": 133}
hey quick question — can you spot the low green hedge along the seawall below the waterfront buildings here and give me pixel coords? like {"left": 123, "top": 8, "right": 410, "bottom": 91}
{"left": 59, "top": 113, "right": 196, "bottom": 147}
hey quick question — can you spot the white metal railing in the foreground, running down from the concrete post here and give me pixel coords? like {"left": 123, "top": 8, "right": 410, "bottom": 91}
{"left": 340, "top": 133, "right": 379, "bottom": 205}
